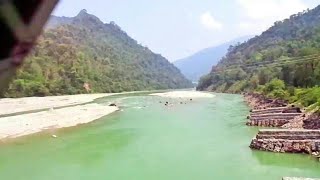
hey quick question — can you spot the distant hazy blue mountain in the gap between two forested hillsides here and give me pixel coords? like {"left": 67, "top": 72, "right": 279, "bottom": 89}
{"left": 174, "top": 36, "right": 252, "bottom": 81}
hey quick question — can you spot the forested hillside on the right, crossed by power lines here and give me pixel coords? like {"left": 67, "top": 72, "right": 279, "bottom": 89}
{"left": 198, "top": 6, "right": 320, "bottom": 109}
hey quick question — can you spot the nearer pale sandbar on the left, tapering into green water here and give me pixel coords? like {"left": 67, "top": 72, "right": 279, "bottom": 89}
{"left": 0, "top": 104, "right": 118, "bottom": 139}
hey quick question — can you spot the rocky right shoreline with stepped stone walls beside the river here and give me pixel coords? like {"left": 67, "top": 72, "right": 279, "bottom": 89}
{"left": 244, "top": 93, "right": 320, "bottom": 157}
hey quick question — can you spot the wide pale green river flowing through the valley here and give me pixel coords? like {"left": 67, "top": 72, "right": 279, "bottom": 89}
{"left": 0, "top": 94, "right": 320, "bottom": 180}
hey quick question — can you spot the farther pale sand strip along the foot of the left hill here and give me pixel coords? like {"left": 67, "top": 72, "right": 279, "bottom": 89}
{"left": 0, "top": 93, "right": 115, "bottom": 115}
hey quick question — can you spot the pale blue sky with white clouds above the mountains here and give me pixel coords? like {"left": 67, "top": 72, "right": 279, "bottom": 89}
{"left": 54, "top": 0, "right": 320, "bottom": 62}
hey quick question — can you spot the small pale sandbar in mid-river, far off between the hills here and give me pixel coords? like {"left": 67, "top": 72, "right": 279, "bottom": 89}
{"left": 150, "top": 91, "right": 215, "bottom": 98}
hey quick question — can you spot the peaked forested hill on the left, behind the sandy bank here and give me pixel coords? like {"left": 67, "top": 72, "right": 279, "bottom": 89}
{"left": 4, "top": 10, "right": 192, "bottom": 97}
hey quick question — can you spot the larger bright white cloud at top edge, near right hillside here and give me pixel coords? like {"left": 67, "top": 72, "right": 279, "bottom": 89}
{"left": 237, "top": 0, "right": 307, "bottom": 21}
